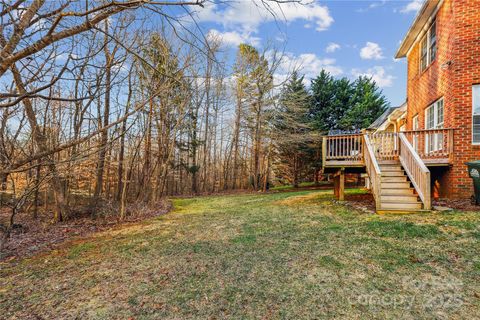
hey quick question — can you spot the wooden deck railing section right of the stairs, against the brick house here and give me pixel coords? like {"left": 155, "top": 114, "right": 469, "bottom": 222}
{"left": 403, "top": 129, "right": 454, "bottom": 163}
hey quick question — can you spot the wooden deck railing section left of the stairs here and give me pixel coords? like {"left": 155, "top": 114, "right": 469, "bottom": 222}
{"left": 323, "top": 134, "right": 363, "bottom": 162}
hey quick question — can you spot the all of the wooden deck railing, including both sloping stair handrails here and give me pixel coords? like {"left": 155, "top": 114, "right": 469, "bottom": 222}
{"left": 323, "top": 129, "right": 446, "bottom": 210}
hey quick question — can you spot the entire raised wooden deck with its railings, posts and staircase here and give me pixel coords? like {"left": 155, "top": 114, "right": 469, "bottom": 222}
{"left": 322, "top": 129, "right": 454, "bottom": 212}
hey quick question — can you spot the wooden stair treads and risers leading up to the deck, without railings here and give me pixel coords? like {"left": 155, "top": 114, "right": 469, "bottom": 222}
{"left": 377, "top": 161, "right": 423, "bottom": 213}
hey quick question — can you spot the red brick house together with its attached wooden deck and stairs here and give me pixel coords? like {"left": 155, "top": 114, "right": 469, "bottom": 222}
{"left": 322, "top": 0, "right": 480, "bottom": 211}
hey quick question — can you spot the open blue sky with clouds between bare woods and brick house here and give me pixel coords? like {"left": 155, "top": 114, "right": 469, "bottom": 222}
{"left": 191, "top": 0, "right": 422, "bottom": 105}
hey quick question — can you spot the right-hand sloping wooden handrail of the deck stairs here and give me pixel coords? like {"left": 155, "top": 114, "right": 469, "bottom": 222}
{"left": 399, "top": 132, "right": 432, "bottom": 210}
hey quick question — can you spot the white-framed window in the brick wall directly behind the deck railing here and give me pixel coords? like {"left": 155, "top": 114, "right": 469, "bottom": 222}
{"left": 425, "top": 98, "right": 443, "bottom": 153}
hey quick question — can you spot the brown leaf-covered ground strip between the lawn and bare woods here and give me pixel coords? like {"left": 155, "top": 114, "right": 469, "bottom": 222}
{"left": 0, "top": 201, "right": 172, "bottom": 262}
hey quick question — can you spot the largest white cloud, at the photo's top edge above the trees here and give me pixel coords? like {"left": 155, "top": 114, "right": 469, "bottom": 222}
{"left": 197, "top": 0, "right": 334, "bottom": 32}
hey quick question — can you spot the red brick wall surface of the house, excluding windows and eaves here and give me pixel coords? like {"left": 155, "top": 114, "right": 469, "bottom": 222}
{"left": 407, "top": 0, "right": 480, "bottom": 198}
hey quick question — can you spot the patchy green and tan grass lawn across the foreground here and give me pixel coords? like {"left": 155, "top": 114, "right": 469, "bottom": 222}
{"left": 0, "top": 190, "right": 480, "bottom": 319}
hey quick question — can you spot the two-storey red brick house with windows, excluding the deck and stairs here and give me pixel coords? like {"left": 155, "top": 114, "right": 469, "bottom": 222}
{"left": 396, "top": 0, "right": 480, "bottom": 198}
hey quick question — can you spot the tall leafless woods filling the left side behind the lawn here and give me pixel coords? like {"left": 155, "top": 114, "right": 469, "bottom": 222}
{"left": 0, "top": 0, "right": 312, "bottom": 248}
